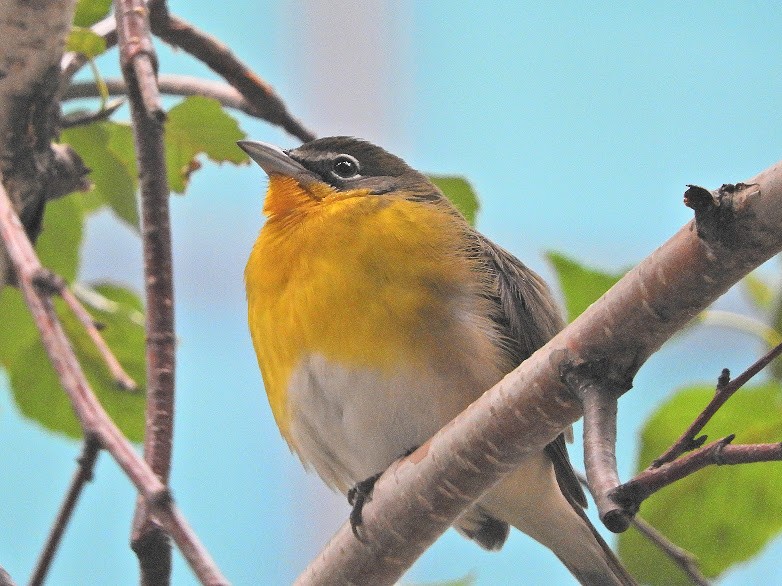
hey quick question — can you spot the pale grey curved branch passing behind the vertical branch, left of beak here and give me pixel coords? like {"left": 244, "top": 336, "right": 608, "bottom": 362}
{"left": 63, "top": 74, "right": 263, "bottom": 118}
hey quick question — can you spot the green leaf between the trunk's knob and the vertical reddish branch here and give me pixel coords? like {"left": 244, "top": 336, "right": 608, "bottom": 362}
{"left": 62, "top": 122, "right": 139, "bottom": 232}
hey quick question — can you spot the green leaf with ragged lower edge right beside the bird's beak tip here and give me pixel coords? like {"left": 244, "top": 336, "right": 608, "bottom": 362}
{"left": 166, "top": 96, "right": 247, "bottom": 193}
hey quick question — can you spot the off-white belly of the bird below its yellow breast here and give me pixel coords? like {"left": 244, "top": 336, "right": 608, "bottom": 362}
{"left": 288, "top": 354, "right": 503, "bottom": 492}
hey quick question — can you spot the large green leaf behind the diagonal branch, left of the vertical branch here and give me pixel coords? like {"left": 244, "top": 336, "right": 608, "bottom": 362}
{"left": 8, "top": 285, "right": 146, "bottom": 442}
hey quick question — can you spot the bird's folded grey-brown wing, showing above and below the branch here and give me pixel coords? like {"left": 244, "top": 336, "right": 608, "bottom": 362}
{"left": 476, "top": 232, "right": 587, "bottom": 507}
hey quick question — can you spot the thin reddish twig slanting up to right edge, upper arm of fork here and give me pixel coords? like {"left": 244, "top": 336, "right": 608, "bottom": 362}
{"left": 650, "top": 344, "right": 782, "bottom": 468}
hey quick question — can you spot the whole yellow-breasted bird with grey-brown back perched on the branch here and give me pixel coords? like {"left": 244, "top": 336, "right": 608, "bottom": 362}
{"left": 237, "top": 136, "right": 635, "bottom": 586}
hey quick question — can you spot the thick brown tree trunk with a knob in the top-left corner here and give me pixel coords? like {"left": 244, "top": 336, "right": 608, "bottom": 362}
{"left": 0, "top": 0, "right": 84, "bottom": 288}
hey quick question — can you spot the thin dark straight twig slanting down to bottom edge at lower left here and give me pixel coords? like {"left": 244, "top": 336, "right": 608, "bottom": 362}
{"left": 30, "top": 434, "right": 100, "bottom": 586}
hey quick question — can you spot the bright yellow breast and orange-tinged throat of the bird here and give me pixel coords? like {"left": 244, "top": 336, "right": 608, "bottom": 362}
{"left": 245, "top": 177, "right": 490, "bottom": 442}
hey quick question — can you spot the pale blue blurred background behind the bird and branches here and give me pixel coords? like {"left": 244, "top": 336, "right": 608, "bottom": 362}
{"left": 0, "top": 0, "right": 782, "bottom": 585}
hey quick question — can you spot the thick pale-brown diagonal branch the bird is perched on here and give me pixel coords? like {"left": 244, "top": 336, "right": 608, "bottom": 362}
{"left": 298, "top": 163, "right": 782, "bottom": 584}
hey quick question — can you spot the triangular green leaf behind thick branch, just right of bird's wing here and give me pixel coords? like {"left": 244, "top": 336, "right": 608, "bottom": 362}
{"left": 546, "top": 252, "right": 626, "bottom": 322}
